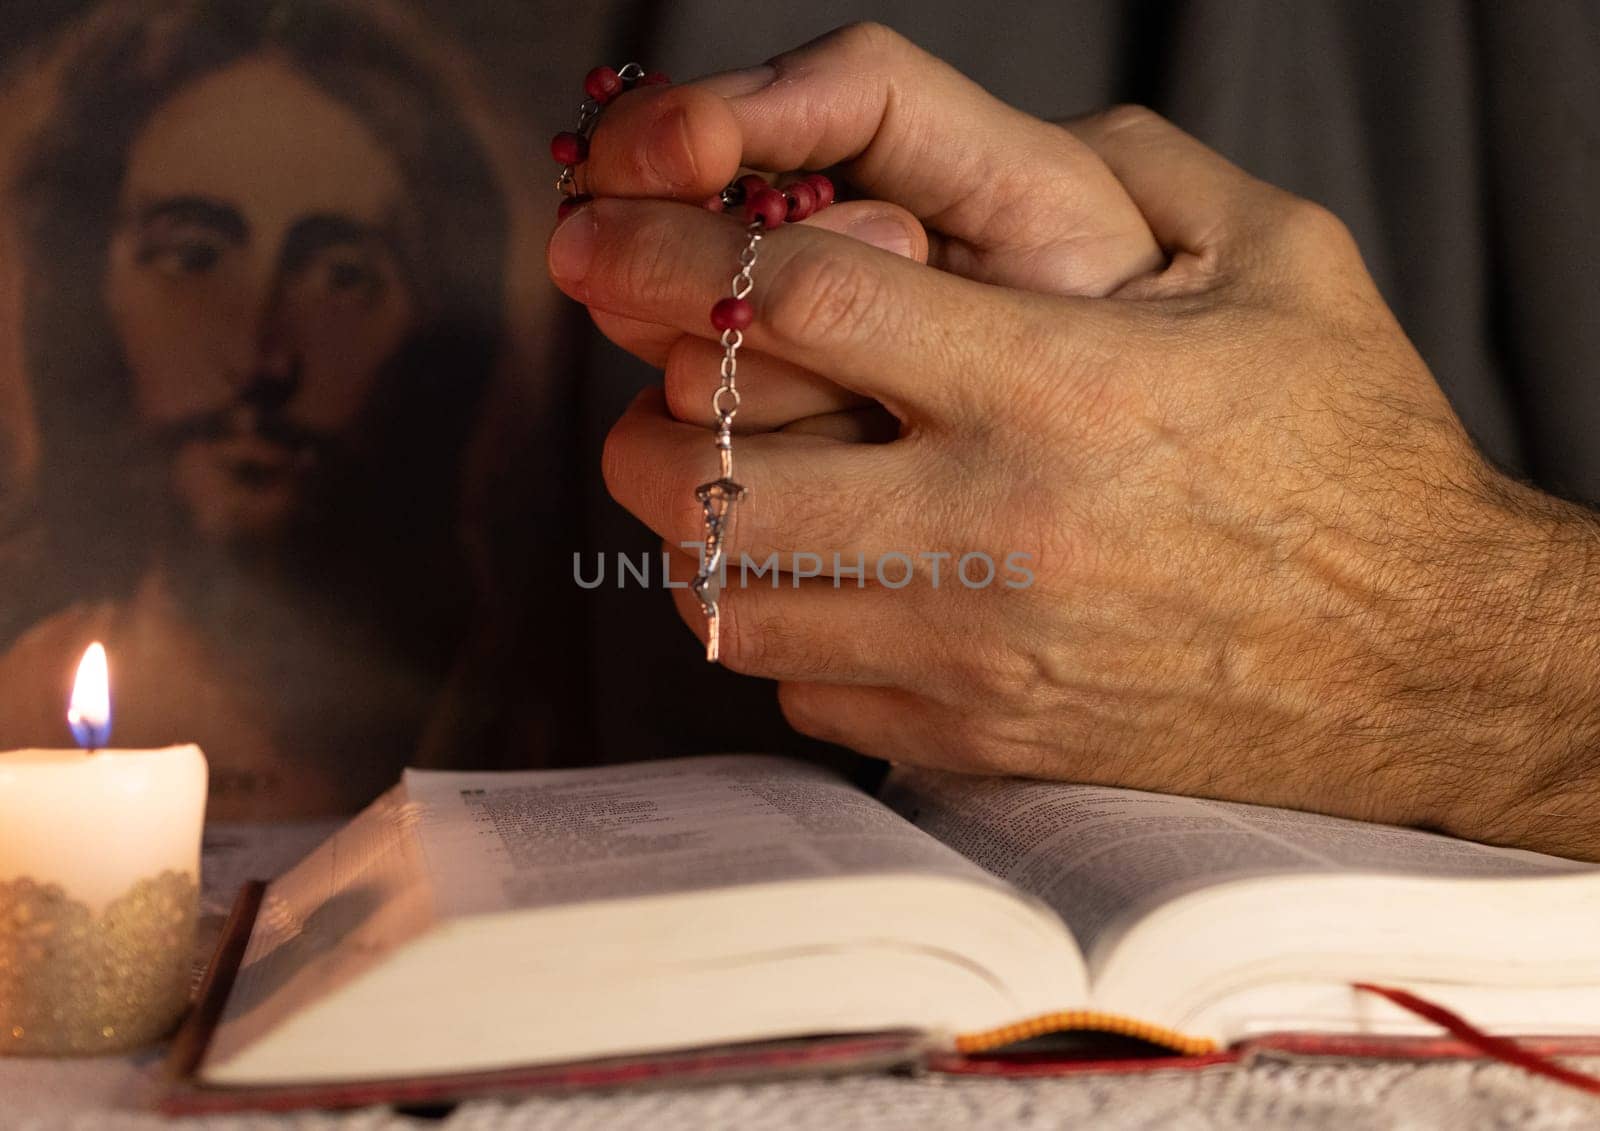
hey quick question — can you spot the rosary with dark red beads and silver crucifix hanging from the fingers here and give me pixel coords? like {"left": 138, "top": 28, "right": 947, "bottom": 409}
{"left": 550, "top": 62, "right": 834, "bottom": 662}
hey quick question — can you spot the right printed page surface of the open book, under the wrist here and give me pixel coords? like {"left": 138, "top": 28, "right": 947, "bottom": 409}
{"left": 882, "top": 769, "right": 1594, "bottom": 968}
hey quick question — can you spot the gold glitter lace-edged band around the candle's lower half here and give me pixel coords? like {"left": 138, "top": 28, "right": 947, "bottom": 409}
{"left": 0, "top": 872, "right": 200, "bottom": 1056}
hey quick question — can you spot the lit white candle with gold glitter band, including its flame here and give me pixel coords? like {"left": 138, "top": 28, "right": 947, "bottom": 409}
{"left": 0, "top": 643, "right": 206, "bottom": 1056}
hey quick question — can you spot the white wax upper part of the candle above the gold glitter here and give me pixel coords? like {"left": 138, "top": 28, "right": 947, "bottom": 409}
{"left": 0, "top": 745, "right": 206, "bottom": 913}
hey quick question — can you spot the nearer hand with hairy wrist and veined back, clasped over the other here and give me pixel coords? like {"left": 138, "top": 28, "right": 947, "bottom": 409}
{"left": 552, "top": 30, "right": 1600, "bottom": 857}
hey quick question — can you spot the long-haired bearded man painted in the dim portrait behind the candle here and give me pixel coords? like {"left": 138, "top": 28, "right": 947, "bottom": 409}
{"left": 0, "top": 0, "right": 507, "bottom": 819}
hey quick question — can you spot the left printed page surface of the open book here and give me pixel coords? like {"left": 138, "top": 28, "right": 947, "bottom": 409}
{"left": 405, "top": 755, "right": 994, "bottom": 915}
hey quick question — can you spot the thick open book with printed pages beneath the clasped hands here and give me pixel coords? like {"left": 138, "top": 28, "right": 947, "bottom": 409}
{"left": 197, "top": 755, "right": 1600, "bottom": 1086}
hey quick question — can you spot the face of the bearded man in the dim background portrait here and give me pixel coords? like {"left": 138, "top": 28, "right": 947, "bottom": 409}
{"left": 106, "top": 56, "right": 418, "bottom": 542}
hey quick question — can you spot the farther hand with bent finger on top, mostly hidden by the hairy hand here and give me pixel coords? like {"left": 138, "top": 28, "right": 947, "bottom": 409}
{"left": 568, "top": 24, "right": 1163, "bottom": 438}
